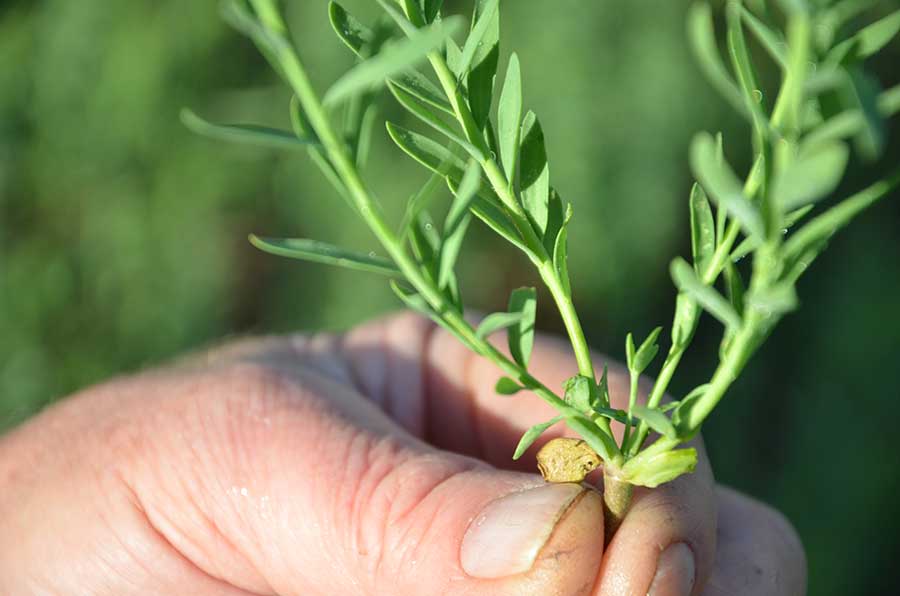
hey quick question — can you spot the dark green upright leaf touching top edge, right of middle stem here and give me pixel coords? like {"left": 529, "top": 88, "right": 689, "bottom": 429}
{"left": 457, "top": 0, "right": 500, "bottom": 130}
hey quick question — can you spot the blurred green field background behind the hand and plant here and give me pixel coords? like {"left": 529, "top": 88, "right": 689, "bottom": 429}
{"left": 0, "top": 0, "right": 900, "bottom": 596}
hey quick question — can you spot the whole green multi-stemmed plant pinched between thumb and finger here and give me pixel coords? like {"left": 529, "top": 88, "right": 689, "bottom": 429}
{"left": 183, "top": 0, "right": 900, "bottom": 534}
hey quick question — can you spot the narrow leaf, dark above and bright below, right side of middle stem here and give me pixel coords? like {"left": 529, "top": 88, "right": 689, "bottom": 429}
{"left": 519, "top": 112, "right": 550, "bottom": 237}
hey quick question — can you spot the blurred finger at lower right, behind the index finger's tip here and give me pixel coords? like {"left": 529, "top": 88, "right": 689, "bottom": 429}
{"left": 702, "top": 487, "right": 806, "bottom": 596}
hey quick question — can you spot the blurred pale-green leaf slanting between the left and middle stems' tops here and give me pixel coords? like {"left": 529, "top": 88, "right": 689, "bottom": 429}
{"left": 324, "top": 18, "right": 461, "bottom": 105}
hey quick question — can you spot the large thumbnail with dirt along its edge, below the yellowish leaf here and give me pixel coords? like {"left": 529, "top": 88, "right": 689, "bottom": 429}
{"left": 460, "top": 484, "right": 585, "bottom": 579}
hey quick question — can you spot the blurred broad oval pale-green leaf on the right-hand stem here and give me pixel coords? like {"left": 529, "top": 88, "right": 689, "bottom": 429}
{"left": 772, "top": 142, "right": 850, "bottom": 211}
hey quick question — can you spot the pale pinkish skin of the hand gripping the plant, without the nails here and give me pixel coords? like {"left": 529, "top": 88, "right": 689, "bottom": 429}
{"left": 0, "top": 314, "right": 806, "bottom": 596}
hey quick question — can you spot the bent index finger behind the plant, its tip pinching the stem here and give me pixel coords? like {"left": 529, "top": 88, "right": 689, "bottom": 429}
{"left": 344, "top": 315, "right": 716, "bottom": 594}
